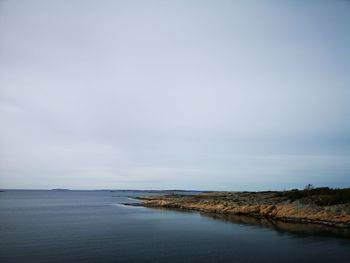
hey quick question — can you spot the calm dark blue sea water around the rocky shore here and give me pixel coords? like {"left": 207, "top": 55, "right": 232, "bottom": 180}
{"left": 0, "top": 191, "right": 350, "bottom": 263}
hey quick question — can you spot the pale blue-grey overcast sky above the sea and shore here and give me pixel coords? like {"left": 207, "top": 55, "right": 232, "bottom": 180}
{"left": 0, "top": 0, "right": 350, "bottom": 191}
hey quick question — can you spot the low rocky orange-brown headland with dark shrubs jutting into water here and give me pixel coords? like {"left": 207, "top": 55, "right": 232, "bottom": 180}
{"left": 126, "top": 188, "right": 350, "bottom": 228}
